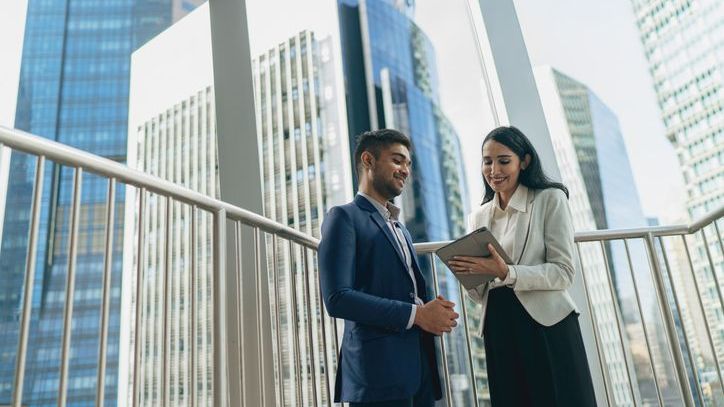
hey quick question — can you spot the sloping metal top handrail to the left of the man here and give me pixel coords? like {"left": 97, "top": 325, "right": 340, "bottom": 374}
{"left": 0, "top": 126, "right": 319, "bottom": 249}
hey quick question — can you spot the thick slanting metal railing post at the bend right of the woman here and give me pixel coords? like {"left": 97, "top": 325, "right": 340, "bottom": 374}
{"left": 644, "top": 232, "right": 694, "bottom": 407}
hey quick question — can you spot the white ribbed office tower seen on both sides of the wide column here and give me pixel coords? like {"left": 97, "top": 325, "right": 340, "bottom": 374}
{"left": 127, "top": 5, "right": 351, "bottom": 406}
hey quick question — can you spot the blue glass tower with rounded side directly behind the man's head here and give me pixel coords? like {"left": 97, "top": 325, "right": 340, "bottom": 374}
{"left": 337, "top": 0, "right": 476, "bottom": 405}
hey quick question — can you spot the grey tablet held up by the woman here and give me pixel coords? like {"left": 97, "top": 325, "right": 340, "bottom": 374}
{"left": 435, "top": 227, "right": 513, "bottom": 290}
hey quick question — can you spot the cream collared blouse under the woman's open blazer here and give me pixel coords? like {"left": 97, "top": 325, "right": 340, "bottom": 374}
{"left": 489, "top": 184, "right": 528, "bottom": 290}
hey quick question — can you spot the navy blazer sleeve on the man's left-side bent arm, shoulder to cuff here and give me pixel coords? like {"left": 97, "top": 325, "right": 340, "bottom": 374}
{"left": 319, "top": 207, "right": 412, "bottom": 331}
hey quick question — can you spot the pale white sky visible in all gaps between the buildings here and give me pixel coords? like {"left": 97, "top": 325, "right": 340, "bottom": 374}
{"left": 0, "top": 0, "right": 685, "bottom": 224}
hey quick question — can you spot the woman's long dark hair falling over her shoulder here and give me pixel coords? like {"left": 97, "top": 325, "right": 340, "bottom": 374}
{"left": 481, "top": 126, "right": 568, "bottom": 204}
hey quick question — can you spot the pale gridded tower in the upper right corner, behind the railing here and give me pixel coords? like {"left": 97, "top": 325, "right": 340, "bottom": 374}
{"left": 631, "top": 0, "right": 724, "bottom": 370}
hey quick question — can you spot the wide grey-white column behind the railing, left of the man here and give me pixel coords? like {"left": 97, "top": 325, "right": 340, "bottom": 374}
{"left": 209, "top": 0, "right": 276, "bottom": 406}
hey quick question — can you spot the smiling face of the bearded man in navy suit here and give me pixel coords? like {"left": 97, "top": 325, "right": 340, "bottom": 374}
{"left": 363, "top": 144, "right": 412, "bottom": 199}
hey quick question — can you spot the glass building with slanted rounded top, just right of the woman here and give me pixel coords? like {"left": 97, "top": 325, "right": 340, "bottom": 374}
{"left": 535, "top": 67, "right": 702, "bottom": 404}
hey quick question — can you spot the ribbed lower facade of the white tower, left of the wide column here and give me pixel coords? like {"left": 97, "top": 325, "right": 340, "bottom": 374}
{"left": 126, "top": 87, "right": 219, "bottom": 406}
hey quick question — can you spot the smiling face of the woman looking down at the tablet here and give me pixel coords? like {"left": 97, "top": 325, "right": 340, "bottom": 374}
{"left": 483, "top": 140, "right": 527, "bottom": 196}
